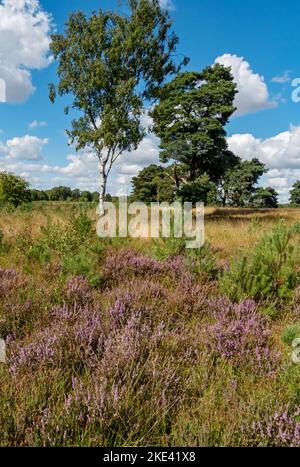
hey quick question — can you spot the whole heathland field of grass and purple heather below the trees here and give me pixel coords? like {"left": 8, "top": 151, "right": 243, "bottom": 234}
{"left": 0, "top": 203, "right": 300, "bottom": 446}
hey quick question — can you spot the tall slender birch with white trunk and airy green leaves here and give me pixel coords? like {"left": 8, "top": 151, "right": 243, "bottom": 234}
{"left": 49, "top": 0, "right": 187, "bottom": 214}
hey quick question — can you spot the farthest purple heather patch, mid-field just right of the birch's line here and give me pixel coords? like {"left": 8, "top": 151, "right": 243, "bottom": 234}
{"left": 102, "top": 250, "right": 186, "bottom": 285}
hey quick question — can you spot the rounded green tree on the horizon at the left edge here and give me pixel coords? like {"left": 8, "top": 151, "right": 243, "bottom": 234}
{"left": 0, "top": 172, "right": 30, "bottom": 206}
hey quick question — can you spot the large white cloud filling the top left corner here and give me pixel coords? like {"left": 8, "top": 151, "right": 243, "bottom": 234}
{"left": 0, "top": 0, "right": 51, "bottom": 103}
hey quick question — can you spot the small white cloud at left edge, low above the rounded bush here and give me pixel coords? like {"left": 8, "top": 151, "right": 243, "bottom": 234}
{"left": 0, "top": 135, "right": 48, "bottom": 161}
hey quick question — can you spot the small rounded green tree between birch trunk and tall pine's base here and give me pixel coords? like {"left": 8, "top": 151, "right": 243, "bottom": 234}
{"left": 132, "top": 164, "right": 174, "bottom": 203}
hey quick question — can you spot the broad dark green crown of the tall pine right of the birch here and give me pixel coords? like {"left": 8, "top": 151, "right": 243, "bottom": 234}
{"left": 151, "top": 65, "right": 236, "bottom": 182}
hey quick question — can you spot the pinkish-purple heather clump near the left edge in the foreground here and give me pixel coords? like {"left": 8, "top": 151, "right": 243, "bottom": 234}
{"left": 9, "top": 305, "right": 104, "bottom": 375}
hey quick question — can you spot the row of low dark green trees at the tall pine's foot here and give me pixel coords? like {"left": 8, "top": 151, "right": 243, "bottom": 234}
{"left": 132, "top": 163, "right": 282, "bottom": 208}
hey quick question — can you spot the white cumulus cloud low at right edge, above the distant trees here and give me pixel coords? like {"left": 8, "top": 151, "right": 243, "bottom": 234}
{"left": 228, "top": 126, "right": 300, "bottom": 201}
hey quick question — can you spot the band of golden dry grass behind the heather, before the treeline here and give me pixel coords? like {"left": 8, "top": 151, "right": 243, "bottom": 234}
{"left": 0, "top": 202, "right": 300, "bottom": 258}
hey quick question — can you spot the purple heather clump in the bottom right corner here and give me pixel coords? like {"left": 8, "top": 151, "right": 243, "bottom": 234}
{"left": 253, "top": 406, "right": 300, "bottom": 448}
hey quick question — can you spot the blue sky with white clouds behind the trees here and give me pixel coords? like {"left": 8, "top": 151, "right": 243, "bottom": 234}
{"left": 0, "top": 0, "right": 300, "bottom": 201}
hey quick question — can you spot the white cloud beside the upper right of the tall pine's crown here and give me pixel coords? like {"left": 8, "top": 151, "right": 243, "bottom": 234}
{"left": 215, "top": 54, "right": 277, "bottom": 116}
